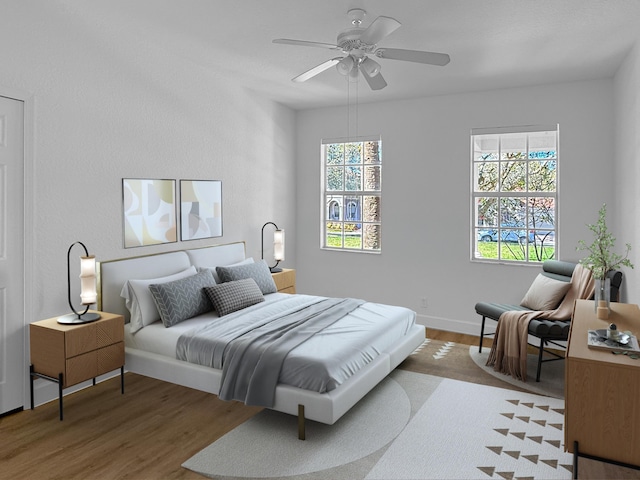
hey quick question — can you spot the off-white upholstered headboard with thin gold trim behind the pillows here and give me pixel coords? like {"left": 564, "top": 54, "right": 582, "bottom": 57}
{"left": 98, "top": 242, "right": 245, "bottom": 322}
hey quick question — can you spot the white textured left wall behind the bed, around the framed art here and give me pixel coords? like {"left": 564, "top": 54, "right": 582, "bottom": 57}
{"left": 0, "top": 0, "right": 296, "bottom": 330}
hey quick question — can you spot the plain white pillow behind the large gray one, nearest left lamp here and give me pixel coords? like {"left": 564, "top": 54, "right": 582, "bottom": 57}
{"left": 120, "top": 267, "right": 198, "bottom": 333}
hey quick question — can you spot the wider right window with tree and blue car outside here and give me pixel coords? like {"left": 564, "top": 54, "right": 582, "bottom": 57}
{"left": 471, "top": 125, "right": 558, "bottom": 263}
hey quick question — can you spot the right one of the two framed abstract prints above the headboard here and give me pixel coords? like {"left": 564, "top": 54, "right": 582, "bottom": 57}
{"left": 180, "top": 180, "right": 222, "bottom": 241}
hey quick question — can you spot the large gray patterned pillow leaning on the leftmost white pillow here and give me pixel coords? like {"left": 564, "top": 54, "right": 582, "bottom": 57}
{"left": 149, "top": 270, "right": 216, "bottom": 328}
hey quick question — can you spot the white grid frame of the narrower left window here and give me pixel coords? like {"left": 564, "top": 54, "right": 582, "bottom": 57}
{"left": 320, "top": 135, "right": 383, "bottom": 254}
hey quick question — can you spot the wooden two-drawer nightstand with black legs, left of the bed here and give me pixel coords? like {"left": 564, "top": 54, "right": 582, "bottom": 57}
{"left": 29, "top": 312, "right": 124, "bottom": 420}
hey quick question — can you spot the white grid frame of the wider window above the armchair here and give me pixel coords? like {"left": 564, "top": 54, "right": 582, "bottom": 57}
{"left": 470, "top": 124, "right": 560, "bottom": 265}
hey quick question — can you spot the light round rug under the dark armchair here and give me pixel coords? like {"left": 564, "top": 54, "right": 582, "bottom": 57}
{"left": 469, "top": 345, "right": 564, "bottom": 398}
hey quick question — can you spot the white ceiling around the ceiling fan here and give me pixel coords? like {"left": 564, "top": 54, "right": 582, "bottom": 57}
{"left": 62, "top": 0, "right": 640, "bottom": 109}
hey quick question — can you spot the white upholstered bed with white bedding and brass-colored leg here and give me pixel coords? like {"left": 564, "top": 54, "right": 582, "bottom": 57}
{"left": 98, "top": 242, "right": 425, "bottom": 439}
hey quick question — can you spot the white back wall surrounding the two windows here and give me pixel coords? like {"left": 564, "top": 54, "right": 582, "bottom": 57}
{"left": 297, "top": 80, "right": 614, "bottom": 334}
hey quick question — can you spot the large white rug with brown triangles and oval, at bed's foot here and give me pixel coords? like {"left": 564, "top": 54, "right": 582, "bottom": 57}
{"left": 183, "top": 370, "right": 572, "bottom": 480}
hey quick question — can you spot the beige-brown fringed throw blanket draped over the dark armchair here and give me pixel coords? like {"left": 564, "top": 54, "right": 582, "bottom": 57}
{"left": 487, "top": 264, "right": 595, "bottom": 382}
